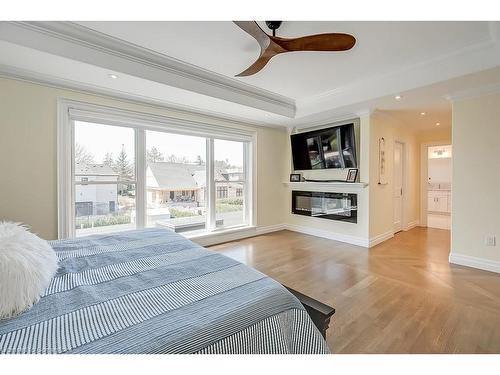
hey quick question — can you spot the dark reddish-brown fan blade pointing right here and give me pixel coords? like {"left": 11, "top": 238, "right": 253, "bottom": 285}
{"left": 269, "top": 33, "right": 356, "bottom": 52}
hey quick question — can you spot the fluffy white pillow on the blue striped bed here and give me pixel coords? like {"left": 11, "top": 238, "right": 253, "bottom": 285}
{"left": 0, "top": 222, "right": 57, "bottom": 319}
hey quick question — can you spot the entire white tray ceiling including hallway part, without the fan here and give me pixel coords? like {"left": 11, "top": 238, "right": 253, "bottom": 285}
{"left": 0, "top": 21, "right": 500, "bottom": 129}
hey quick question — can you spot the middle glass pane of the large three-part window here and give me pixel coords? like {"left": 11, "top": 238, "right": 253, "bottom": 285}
{"left": 146, "top": 130, "right": 207, "bottom": 232}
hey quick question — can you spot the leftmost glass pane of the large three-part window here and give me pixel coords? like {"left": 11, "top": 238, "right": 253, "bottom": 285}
{"left": 73, "top": 121, "right": 136, "bottom": 236}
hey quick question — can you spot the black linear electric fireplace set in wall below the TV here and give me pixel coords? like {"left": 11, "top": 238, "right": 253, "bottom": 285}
{"left": 292, "top": 190, "right": 358, "bottom": 223}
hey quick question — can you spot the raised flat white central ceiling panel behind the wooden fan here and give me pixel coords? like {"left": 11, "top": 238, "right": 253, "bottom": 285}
{"left": 80, "top": 21, "right": 490, "bottom": 99}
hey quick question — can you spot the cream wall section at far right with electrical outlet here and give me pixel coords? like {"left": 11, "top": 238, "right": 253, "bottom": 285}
{"left": 450, "top": 94, "right": 500, "bottom": 272}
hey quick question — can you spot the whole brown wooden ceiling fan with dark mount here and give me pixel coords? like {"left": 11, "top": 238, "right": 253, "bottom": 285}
{"left": 234, "top": 21, "right": 356, "bottom": 77}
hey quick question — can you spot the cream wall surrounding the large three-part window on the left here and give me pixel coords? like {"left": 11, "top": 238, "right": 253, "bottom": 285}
{"left": 0, "top": 78, "right": 288, "bottom": 239}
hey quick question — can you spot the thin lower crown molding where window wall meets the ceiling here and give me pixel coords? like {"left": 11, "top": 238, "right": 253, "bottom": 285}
{"left": 0, "top": 64, "right": 286, "bottom": 128}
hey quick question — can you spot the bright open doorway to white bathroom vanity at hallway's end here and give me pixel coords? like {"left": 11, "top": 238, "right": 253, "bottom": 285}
{"left": 427, "top": 145, "right": 452, "bottom": 230}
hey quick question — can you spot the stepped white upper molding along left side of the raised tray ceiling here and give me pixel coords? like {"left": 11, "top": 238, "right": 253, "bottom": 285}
{"left": 0, "top": 21, "right": 296, "bottom": 118}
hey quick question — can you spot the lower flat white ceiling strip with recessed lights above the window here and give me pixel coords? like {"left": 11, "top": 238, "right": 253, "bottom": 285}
{"left": 0, "top": 40, "right": 281, "bottom": 122}
